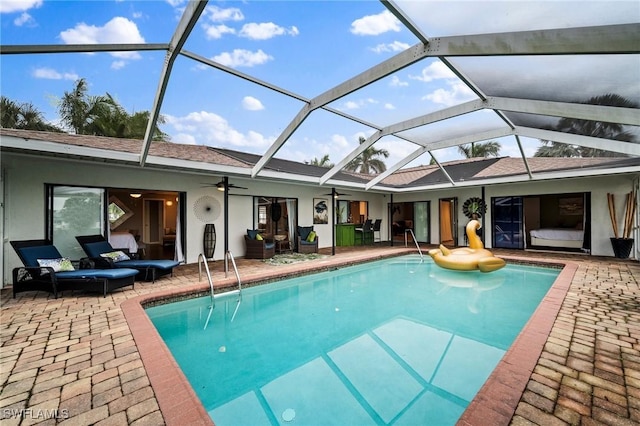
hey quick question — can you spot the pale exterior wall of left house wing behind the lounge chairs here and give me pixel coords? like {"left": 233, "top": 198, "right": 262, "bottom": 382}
{"left": 0, "top": 153, "right": 386, "bottom": 285}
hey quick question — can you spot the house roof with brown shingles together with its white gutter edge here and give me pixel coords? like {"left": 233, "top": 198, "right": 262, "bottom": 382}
{"left": 0, "top": 129, "right": 640, "bottom": 191}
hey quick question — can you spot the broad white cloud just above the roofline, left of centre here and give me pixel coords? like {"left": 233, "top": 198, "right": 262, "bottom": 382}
{"left": 165, "top": 111, "right": 275, "bottom": 152}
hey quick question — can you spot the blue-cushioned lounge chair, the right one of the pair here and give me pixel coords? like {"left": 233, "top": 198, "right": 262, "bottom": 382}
{"left": 76, "top": 235, "right": 180, "bottom": 282}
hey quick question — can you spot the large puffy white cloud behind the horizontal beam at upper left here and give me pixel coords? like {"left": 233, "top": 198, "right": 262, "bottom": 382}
{"left": 60, "top": 16, "right": 145, "bottom": 59}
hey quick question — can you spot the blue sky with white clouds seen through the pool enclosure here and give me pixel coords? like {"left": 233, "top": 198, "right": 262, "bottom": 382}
{"left": 0, "top": 0, "right": 640, "bottom": 165}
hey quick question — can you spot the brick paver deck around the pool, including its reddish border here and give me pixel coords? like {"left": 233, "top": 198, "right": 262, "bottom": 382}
{"left": 0, "top": 247, "right": 640, "bottom": 426}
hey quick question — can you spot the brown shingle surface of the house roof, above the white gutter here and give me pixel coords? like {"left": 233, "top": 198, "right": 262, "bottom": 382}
{"left": 0, "top": 128, "right": 640, "bottom": 188}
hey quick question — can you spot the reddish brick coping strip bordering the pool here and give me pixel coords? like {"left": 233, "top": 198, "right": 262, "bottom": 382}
{"left": 120, "top": 253, "right": 578, "bottom": 426}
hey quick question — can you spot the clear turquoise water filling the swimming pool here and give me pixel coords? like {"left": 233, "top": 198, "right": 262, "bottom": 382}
{"left": 147, "top": 256, "right": 559, "bottom": 426}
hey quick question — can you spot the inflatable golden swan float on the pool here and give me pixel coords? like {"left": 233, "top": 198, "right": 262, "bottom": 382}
{"left": 429, "top": 220, "right": 506, "bottom": 272}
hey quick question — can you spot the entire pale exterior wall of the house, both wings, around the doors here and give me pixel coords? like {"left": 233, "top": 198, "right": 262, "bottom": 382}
{"left": 0, "top": 153, "right": 640, "bottom": 285}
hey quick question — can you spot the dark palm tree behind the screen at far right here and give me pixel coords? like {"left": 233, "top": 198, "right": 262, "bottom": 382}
{"left": 535, "top": 93, "right": 638, "bottom": 157}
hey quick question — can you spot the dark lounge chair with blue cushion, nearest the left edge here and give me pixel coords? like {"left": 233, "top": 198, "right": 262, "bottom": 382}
{"left": 11, "top": 240, "right": 138, "bottom": 299}
